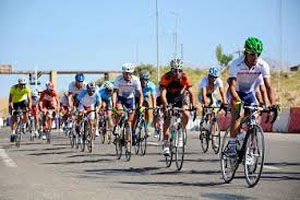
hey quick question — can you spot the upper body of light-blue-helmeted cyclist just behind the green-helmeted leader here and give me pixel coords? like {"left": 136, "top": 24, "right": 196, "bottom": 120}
{"left": 198, "top": 66, "right": 227, "bottom": 106}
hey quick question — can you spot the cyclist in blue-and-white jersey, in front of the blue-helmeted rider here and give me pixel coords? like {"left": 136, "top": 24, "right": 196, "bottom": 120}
{"left": 76, "top": 82, "right": 101, "bottom": 144}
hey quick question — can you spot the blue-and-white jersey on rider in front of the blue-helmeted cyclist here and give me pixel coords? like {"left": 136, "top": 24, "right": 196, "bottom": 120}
{"left": 76, "top": 89, "right": 101, "bottom": 107}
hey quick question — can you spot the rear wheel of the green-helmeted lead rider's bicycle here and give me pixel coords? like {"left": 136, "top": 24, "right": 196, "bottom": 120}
{"left": 220, "top": 128, "right": 238, "bottom": 183}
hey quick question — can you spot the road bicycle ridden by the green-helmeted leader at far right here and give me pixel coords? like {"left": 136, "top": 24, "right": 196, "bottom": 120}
{"left": 220, "top": 105, "right": 279, "bottom": 187}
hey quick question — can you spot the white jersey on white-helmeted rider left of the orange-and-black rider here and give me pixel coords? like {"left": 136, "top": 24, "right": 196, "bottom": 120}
{"left": 114, "top": 75, "right": 142, "bottom": 98}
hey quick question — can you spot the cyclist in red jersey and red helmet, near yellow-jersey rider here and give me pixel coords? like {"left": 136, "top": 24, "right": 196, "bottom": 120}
{"left": 40, "top": 81, "right": 59, "bottom": 140}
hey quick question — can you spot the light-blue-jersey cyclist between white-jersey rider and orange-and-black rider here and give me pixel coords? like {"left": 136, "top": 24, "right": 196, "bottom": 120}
{"left": 135, "top": 70, "right": 156, "bottom": 137}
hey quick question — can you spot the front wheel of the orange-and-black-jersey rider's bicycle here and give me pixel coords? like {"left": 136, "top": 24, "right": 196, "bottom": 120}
{"left": 175, "top": 124, "right": 185, "bottom": 171}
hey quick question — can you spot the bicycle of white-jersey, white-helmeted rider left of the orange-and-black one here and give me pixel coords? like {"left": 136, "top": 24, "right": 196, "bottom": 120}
{"left": 113, "top": 107, "right": 132, "bottom": 161}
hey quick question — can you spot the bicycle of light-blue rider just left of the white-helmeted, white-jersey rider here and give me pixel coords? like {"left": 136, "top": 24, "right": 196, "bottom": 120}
{"left": 98, "top": 110, "right": 112, "bottom": 144}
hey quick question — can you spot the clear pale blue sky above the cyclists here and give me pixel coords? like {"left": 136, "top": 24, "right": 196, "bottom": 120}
{"left": 0, "top": 0, "right": 300, "bottom": 96}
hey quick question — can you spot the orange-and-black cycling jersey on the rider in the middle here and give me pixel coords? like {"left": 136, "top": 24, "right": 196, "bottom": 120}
{"left": 160, "top": 71, "right": 192, "bottom": 95}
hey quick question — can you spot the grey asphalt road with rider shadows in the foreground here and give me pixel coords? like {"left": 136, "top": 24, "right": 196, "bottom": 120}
{"left": 0, "top": 129, "right": 300, "bottom": 200}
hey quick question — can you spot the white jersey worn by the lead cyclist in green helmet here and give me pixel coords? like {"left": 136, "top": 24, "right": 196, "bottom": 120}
{"left": 229, "top": 56, "right": 270, "bottom": 93}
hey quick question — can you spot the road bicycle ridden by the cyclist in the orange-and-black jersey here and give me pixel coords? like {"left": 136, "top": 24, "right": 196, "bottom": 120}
{"left": 165, "top": 105, "right": 196, "bottom": 171}
